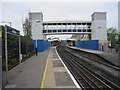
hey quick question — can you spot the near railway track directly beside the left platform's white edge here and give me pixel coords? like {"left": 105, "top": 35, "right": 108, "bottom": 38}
{"left": 57, "top": 47, "right": 119, "bottom": 90}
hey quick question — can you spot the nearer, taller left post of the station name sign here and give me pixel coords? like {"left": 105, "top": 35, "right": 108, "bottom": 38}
{"left": 5, "top": 25, "right": 8, "bottom": 84}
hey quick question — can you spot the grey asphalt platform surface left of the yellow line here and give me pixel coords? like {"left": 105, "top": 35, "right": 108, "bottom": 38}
{"left": 6, "top": 49, "right": 50, "bottom": 88}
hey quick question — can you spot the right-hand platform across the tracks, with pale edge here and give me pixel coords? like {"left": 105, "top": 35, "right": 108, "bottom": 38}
{"left": 68, "top": 46, "right": 120, "bottom": 67}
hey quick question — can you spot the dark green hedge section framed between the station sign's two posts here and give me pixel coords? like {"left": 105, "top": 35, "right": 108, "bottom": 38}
{"left": 7, "top": 34, "right": 19, "bottom": 69}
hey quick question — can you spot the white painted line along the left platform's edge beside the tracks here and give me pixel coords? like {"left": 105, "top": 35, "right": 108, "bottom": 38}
{"left": 55, "top": 48, "right": 82, "bottom": 90}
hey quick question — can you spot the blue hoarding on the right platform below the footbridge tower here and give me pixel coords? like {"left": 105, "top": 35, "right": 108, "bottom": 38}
{"left": 76, "top": 40, "right": 99, "bottom": 50}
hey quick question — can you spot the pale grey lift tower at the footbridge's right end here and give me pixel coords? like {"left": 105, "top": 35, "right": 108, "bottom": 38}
{"left": 91, "top": 12, "right": 107, "bottom": 40}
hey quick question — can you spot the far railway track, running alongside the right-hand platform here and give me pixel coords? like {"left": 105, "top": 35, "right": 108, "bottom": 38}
{"left": 65, "top": 47, "right": 120, "bottom": 87}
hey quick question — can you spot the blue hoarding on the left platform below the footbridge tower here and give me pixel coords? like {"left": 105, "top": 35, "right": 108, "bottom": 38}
{"left": 33, "top": 40, "right": 51, "bottom": 52}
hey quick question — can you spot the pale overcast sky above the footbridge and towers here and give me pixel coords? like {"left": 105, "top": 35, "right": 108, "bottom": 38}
{"left": 0, "top": 0, "right": 119, "bottom": 39}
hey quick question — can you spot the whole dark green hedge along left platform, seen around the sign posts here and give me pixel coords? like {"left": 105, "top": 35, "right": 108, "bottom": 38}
{"left": 2, "top": 26, "right": 33, "bottom": 70}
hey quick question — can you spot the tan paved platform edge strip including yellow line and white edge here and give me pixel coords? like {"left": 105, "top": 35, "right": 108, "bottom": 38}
{"left": 41, "top": 47, "right": 79, "bottom": 88}
